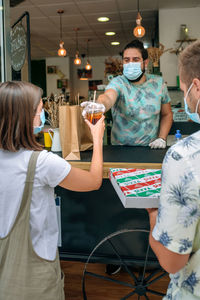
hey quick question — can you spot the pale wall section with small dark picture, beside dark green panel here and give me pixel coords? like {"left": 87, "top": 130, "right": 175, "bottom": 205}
{"left": 46, "top": 57, "right": 70, "bottom": 96}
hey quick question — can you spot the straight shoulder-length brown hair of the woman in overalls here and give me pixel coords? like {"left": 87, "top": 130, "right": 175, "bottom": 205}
{"left": 0, "top": 81, "right": 42, "bottom": 152}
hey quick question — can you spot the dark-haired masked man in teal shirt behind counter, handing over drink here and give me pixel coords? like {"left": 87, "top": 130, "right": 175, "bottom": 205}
{"left": 97, "top": 40, "right": 173, "bottom": 148}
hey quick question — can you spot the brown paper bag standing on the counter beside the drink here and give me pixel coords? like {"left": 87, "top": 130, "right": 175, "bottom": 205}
{"left": 59, "top": 105, "right": 92, "bottom": 160}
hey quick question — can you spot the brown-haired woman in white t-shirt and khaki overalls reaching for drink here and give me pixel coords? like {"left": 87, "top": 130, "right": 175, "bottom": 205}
{"left": 0, "top": 81, "right": 105, "bottom": 300}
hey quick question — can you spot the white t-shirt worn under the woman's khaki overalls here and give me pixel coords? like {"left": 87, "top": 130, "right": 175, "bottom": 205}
{"left": 0, "top": 149, "right": 71, "bottom": 260}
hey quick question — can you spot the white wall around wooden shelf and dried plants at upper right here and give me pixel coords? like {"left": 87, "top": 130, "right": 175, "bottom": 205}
{"left": 159, "top": 7, "right": 200, "bottom": 86}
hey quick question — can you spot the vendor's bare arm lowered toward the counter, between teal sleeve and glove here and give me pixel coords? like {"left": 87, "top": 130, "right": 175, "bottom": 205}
{"left": 158, "top": 103, "right": 173, "bottom": 140}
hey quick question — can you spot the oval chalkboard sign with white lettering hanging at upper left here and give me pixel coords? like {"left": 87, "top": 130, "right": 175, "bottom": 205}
{"left": 11, "top": 24, "right": 26, "bottom": 71}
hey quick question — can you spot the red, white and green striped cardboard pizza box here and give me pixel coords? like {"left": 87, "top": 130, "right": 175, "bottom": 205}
{"left": 109, "top": 168, "right": 161, "bottom": 208}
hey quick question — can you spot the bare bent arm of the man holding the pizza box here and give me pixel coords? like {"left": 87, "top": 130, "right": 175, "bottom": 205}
{"left": 147, "top": 209, "right": 190, "bottom": 274}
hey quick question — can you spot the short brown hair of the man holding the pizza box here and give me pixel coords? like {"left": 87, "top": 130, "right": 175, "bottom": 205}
{"left": 179, "top": 40, "right": 200, "bottom": 88}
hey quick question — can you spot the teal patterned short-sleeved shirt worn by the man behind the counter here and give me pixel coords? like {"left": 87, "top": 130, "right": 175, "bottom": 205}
{"left": 106, "top": 74, "right": 170, "bottom": 146}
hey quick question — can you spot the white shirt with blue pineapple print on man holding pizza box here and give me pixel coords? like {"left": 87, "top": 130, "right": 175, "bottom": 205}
{"left": 152, "top": 131, "right": 200, "bottom": 300}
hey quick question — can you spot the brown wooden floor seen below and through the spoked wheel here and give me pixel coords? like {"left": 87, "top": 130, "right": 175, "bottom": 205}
{"left": 61, "top": 261, "right": 169, "bottom": 300}
